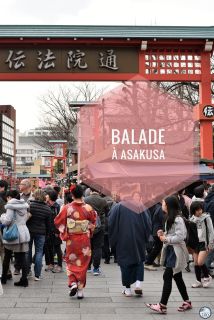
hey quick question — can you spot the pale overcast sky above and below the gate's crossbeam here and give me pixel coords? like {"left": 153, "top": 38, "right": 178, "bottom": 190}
{"left": 0, "top": 0, "right": 214, "bottom": 130}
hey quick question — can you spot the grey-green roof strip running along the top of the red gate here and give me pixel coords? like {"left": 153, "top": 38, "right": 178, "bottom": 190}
{"left": 0, "top": 25, "right": 214, "bottom": 39}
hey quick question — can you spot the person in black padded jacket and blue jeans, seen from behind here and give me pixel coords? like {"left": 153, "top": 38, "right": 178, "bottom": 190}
{"left": 27, "top": 190, "right": 52, "bottom": 281}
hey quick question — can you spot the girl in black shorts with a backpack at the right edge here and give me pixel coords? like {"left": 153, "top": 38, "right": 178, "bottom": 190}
{"left": 190, "top": 201, "right": 214, "bottom": 288}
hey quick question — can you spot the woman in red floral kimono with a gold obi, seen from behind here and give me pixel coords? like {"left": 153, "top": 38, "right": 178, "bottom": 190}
{"left": 54, "top": 185, "right": 97, "bottom": 299}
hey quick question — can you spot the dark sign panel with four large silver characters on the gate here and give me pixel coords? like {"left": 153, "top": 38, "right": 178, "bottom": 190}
{"left": 0, "top": 46, "right": 138, "bottom": 73}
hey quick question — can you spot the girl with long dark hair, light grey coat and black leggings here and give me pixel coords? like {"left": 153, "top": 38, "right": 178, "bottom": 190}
{"left": 146, "top": 195, "right": 192, "bottom": 314}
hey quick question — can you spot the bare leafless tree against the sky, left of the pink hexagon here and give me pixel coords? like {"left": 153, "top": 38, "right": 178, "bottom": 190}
{"left": 34, "top": 82, "right": 104, "bottom": 165}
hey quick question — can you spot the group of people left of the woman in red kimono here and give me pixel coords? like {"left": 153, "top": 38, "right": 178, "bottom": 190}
{"left": 0, "top": 179, "right": 62, "bottom": 287}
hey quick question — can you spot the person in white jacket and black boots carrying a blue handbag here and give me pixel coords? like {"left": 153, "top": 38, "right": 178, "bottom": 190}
{"left": 0, "top": 190, "right": 30, "bottom": 287}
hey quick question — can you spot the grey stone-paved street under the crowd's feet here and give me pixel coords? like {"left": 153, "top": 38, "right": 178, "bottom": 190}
{"left": 0, "top": 263, "right": 214, "bottom": 320}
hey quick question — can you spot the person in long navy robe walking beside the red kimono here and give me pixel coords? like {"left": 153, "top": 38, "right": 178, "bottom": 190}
{"left": 109, "top": 200, "right": 151, "bottom": 297}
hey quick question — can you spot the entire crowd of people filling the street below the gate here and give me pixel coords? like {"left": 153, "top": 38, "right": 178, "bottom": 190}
{"left": 0, "top": 179, "right": 214, "bottom": 314}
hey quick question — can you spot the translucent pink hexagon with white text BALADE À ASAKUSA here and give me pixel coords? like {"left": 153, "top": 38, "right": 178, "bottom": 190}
{"left": 78, "top": 80, "right": 199, "bottom": 207}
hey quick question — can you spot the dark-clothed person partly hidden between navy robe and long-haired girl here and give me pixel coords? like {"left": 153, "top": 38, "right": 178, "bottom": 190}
{"left": 145, "top": 203, "right": 164, "bottom": 271}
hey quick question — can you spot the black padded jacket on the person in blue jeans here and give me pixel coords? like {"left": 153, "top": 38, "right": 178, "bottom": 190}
{"left": 27, "top": 200, "right": 52, "bottom": 235}
